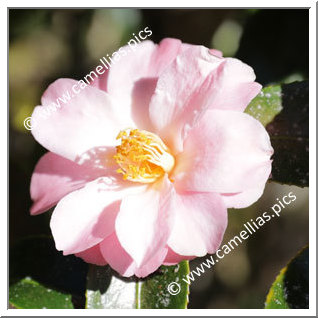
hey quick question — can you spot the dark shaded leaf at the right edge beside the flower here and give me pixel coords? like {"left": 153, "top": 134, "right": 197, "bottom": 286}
{"left": 266, "top": 82, "right": 309, "bottom": 187}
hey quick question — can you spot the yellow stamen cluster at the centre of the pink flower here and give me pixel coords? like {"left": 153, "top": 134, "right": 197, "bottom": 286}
{"left": 114, "top": 129, "right": 175, "bottom": 183}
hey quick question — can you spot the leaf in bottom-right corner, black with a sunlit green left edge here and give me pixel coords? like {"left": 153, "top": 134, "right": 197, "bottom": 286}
{"left": 265, "top": 247, "right": 309, "bottom": 309}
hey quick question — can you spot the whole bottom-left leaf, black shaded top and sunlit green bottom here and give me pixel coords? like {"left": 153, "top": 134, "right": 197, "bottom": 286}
{"left": 9, "top": 236, "right": 88, "bottom": 309}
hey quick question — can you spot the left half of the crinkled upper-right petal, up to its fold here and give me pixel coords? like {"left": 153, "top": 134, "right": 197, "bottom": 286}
{"left": 149, "top": 46, "right": 223, "bottom": 153}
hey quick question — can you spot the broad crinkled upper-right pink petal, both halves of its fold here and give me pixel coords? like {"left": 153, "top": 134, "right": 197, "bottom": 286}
{"left": 149, "top": 46, "right": 261, "bottom": 151}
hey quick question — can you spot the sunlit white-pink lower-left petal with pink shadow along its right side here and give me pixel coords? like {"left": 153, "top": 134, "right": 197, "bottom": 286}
{"left": 50, "top": 177, "right": 144, "bottom": 254}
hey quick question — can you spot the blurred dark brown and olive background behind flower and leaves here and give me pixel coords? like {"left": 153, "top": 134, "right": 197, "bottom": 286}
{"left": 9, "top": 9, "right": 309, "bottom": 308}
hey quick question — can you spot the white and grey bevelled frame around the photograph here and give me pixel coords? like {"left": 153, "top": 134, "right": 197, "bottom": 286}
{"left": 0, "top": 0, "right": 317, "bottom": 316}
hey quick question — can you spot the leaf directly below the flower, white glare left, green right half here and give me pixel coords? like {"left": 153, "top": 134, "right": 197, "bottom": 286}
{"left": 86, "top": 261, "right": 189, "bottom": 309}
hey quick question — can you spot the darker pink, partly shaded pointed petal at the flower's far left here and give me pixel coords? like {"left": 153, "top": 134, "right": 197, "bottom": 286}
{"left": 30, "top": 152, "right": 105, "bottom": 215}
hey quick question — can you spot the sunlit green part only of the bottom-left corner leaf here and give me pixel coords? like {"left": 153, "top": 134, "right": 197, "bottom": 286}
{"left": 9, "top": 278, "right": 74, "bottom": 309}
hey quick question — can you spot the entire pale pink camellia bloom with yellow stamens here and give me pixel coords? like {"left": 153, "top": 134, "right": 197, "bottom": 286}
{"left": 31, "top": 39, "right": 273, "bottom": 277}
